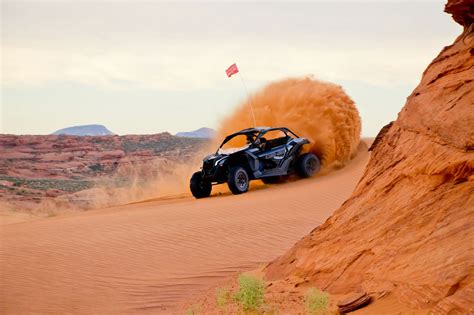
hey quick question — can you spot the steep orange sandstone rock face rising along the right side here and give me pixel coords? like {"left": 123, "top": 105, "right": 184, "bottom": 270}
{"left": 266, "top": 0, "right": 474, "bottom": 313}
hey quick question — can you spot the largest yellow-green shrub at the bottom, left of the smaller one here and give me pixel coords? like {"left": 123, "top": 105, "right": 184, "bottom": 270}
{"left": 234, "top": 274, "right": 265, "bottom": 311}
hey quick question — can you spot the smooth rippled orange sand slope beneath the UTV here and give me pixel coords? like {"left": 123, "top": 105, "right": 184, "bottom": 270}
{"left": 0, "top": 147, "right": 368, "bottom": 314}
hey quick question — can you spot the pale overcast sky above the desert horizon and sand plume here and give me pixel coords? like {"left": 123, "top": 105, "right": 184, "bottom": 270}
{"left": 0, "top": 0, "right": 461, "bottom": 136}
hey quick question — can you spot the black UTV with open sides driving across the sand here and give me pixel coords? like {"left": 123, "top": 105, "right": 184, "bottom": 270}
{"left": 190, "top": 127, "right": 320, "bottom": 198}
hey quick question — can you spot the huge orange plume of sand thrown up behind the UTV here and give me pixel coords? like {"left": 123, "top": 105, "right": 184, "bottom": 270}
{"left": 217, "top": 77, "right": 361, "bottom": 168}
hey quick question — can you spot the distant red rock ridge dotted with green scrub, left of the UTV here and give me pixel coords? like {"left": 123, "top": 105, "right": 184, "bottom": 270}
{"left": 0, "top": 133, "right": 206, "bottom": 209}
